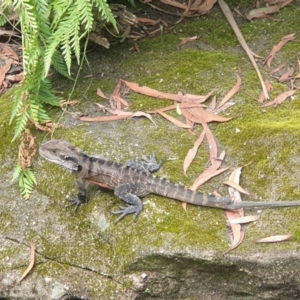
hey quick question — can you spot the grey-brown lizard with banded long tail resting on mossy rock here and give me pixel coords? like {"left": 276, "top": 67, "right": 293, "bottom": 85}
{"left": 39, "top": 140, "right": 300, "bottom": 222}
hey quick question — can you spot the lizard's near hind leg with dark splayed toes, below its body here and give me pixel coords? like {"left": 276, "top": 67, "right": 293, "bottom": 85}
{"left": 112, "top": 183, "right": 145, "bottom": 223}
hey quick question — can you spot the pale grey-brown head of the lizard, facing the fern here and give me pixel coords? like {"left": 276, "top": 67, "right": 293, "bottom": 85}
{"left": 39, "top": 140, "right": 81, "bottom": 171}
